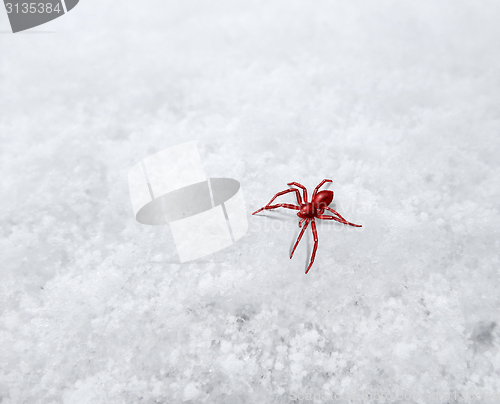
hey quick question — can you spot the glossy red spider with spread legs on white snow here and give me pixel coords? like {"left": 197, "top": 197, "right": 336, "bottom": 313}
{"left": 252, "top": 180, "right": 361, "bottom": 274}
